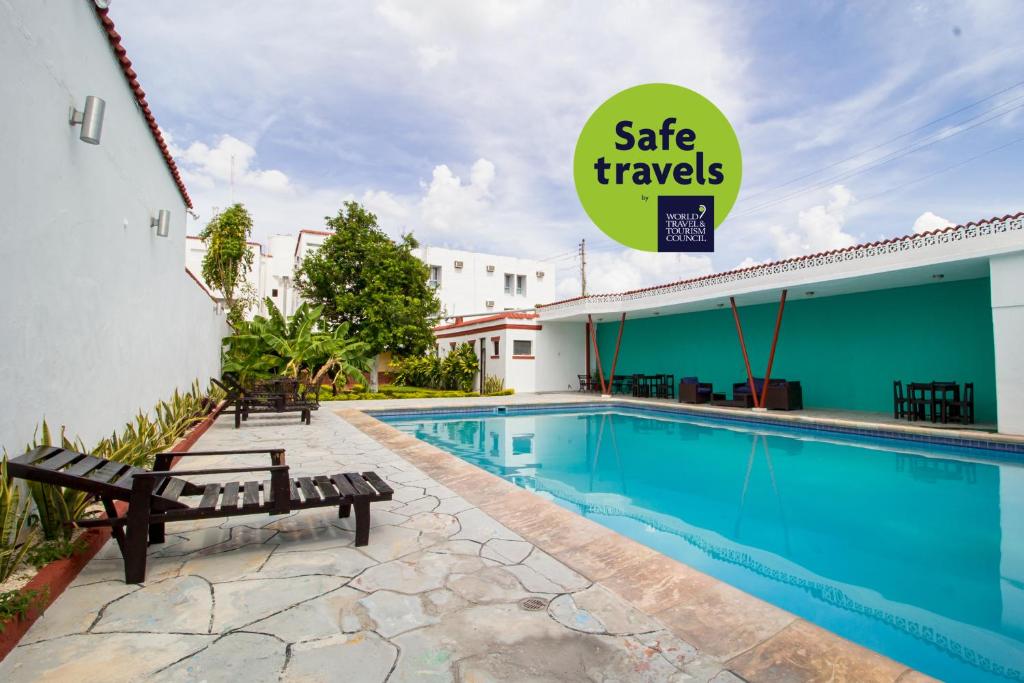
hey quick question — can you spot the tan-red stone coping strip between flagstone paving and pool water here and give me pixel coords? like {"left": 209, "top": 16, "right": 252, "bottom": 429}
{"left": 334, "top": 402, "right": 935, "bottom": 681}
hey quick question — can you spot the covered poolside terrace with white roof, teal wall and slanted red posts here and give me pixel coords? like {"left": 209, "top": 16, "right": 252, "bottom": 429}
{"left": 539, "top": 213, "right": 1024, "bottom": 434}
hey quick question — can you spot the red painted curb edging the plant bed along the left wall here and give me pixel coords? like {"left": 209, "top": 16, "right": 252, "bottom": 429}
{"left": 0, "top": 401, "right": 226, "bottom": 661}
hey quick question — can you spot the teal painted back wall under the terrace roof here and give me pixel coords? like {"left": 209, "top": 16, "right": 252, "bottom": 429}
{"left": 592, "top": 278, "right": 995, "bottom": 422}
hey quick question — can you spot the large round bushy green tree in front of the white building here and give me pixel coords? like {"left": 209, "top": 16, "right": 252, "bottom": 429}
{"left": 295, "top": 202, "right": 440, "bottom": 356}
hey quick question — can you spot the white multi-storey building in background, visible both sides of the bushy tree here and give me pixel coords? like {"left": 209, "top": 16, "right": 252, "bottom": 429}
{"left": 186, "top": 230, "right": 555, "bottom": 319}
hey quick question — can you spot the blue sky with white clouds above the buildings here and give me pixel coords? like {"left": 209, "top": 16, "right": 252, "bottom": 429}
{"left": 111, "top": 0, "right": 1024, "bottom": 296}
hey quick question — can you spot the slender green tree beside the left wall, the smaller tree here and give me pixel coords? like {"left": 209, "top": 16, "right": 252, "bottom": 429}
{"left": 199, "top": 204, "right": 253, "bottom": 327}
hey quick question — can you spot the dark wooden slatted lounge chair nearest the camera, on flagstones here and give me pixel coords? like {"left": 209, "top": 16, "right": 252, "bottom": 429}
{"left": 7, "top": 446, "right": 394, "bottom": 584}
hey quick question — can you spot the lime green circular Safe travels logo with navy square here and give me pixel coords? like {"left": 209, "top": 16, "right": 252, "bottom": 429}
{"left": 572, "top": 83, "right": 742, "bottom": 252}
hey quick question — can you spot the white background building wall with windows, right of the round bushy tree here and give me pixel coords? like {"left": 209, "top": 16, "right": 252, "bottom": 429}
{"left": 413, "top": 247, "right": 555, "bottom": 316}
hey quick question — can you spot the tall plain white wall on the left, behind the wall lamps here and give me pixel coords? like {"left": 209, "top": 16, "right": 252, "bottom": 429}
{"left": 0, "top": 0, "right": 226, "bottom": 454}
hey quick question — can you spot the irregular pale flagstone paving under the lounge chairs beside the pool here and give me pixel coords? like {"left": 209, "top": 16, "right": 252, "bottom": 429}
{"left": 0, "top": 410, "right": 739, "bottom": 683}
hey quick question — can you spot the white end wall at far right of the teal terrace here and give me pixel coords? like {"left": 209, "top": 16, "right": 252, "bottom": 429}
{"left": 989, "top": 252, "right": 1024, "bottom": 434}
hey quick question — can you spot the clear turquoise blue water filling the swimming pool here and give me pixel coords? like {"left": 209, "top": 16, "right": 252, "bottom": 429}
{"left": 381, "top": 408, "right": 1024, "bottom": 681}
